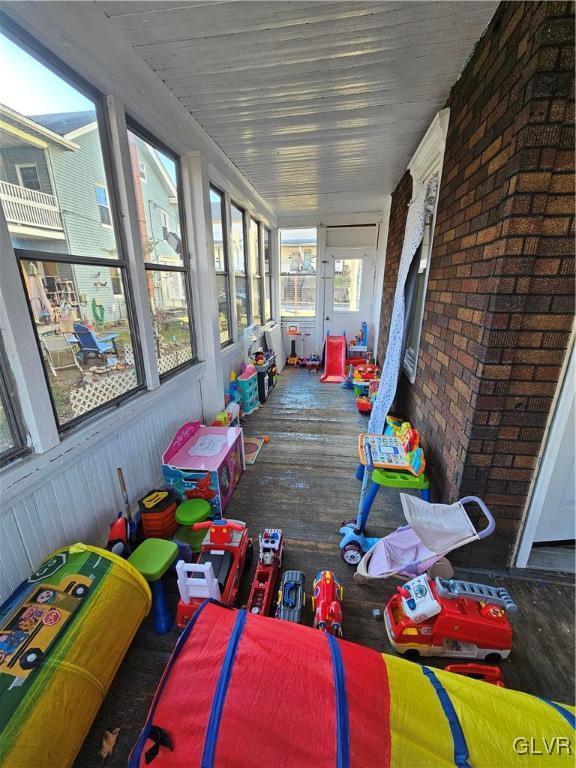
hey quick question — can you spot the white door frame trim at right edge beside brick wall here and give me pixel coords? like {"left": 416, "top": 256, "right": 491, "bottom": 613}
{"left": 512, "top": 329, "right": 576, "bottom": 568}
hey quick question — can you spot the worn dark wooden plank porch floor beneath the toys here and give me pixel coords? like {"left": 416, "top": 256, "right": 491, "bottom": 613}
{"left": 76, "top": 369, "right": 574, "bottom": 768}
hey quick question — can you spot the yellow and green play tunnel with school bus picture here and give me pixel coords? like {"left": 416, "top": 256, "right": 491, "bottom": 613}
{"left": 0, "top": 544, "right": 151, "bottom": 768}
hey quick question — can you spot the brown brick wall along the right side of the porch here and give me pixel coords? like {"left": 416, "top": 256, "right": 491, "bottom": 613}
{"left": 380, "top": 3, "right": 574, "bottom": 565}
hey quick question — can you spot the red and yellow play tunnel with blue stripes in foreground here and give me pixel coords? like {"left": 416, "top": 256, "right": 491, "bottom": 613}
{"left": 129, "top": 601, "right": 574, "bottom": 768}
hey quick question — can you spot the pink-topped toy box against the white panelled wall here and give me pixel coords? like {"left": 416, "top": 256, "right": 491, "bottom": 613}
{"left": 162, "top": 421, "right": 245, "bottom": 517}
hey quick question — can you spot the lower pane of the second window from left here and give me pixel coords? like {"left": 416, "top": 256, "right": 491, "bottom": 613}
{"left": 146, "top": 269, "right": 193, "bottom": 374}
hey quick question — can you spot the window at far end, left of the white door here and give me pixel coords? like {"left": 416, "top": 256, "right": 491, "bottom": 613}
{"left": 280, "top": 229, "right": 316, "bottom": 317}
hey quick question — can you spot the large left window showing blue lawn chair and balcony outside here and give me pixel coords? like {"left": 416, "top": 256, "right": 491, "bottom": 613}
{"left": 0, "top": 30, "right": 142, "bottom": 428}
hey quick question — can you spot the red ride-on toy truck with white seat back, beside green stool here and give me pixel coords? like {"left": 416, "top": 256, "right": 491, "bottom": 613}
{"left": 176, "top": 518, "right": 252, "bottom": 629}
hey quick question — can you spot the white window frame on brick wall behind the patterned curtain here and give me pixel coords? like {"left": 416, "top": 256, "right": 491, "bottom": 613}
{"left": 402, "top": 108, "right": 450, "bottom": 384}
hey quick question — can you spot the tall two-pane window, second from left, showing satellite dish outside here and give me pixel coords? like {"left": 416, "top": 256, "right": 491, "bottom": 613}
{"left": 128, "top": 125, "right": 194, "bottom": 376}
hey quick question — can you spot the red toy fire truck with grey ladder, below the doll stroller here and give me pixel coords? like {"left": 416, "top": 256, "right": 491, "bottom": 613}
{"left": 384, "top": 574, "right": 518, "bottom": 661}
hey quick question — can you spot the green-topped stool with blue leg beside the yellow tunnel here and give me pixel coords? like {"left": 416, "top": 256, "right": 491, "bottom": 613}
{"left": 128, "top": 539, "right": 178, "bottom": 635}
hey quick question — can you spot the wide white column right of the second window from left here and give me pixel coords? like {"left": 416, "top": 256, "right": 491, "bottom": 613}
{"left": 182, "top": 152, "right": 224, "bottom": 424}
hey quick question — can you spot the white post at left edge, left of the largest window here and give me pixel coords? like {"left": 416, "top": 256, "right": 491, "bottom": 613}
{"left": 0, "top": 206, "right": 60, "bottom": 453}
